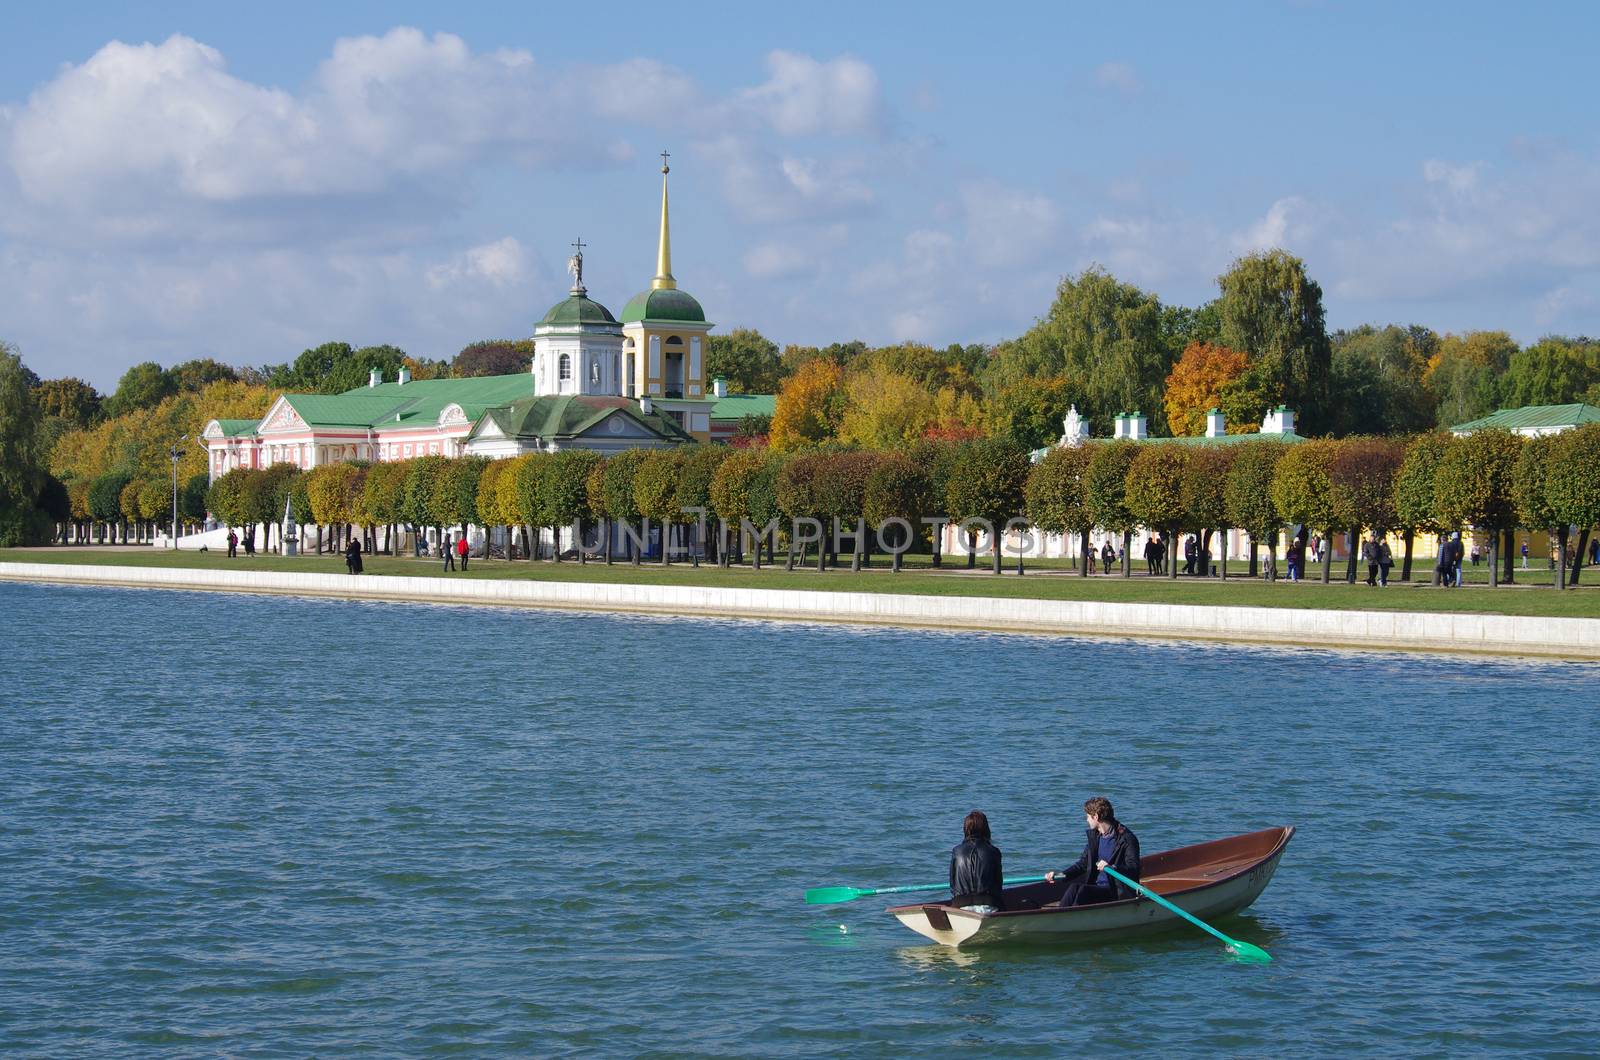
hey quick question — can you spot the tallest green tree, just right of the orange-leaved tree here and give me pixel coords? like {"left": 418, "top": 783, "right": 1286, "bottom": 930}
{"left": 1218, "top": 250, "right": 1331, "bottom": 432}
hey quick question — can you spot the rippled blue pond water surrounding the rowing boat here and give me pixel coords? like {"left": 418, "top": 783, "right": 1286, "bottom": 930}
{"left": 0, "top": 584, "right": 1600, "bottom": 1057}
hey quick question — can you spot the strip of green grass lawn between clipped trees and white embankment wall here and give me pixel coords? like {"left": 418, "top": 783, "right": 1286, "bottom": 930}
{"left": 0, "top": 548, "right": 1600, "bottom": 618}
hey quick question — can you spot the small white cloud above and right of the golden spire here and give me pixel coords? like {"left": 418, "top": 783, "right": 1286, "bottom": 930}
{"left": 742, "top": 51, "right": 886, "bottom": 136}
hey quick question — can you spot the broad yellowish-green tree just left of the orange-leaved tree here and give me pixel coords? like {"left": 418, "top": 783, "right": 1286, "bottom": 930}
{"left": 986, "top": 266, "right": 1176, "bottom": 435}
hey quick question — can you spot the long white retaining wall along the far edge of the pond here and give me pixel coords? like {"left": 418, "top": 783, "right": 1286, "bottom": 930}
{"left": 0, "top": 564, "right": 1600, "bottom": 660}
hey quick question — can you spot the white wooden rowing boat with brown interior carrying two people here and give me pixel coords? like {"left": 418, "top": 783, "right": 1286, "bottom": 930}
{"left": 888, "top": 826, "right": 1294, "bottom": 946}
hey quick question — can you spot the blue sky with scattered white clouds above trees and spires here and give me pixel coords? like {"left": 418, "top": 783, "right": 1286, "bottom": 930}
{"left": 0, "top": 0, "right": 1600, "bottom": 391}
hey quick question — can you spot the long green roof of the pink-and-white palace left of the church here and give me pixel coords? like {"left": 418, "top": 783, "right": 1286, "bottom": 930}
{"left": 283, "top": 371, "right": 533, "bottom": 428}
